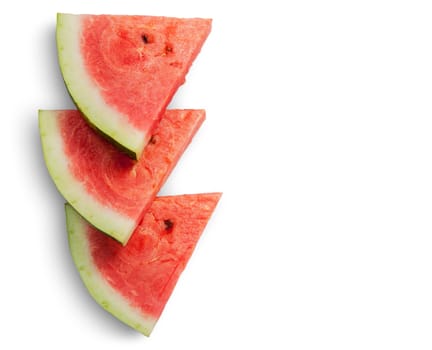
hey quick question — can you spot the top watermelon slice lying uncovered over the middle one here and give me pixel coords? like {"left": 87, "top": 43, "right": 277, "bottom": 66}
{"left": 57, "top": 13, "right": 211, "bottom": 159}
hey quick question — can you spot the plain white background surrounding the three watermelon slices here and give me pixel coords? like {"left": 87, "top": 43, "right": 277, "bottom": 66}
{"left": 0, "top": 0, "right": 432, "bottom": 350}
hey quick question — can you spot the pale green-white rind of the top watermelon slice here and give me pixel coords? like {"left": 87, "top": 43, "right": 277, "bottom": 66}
{"left": 56, "top": 13, "right": 145, "bottom": 159}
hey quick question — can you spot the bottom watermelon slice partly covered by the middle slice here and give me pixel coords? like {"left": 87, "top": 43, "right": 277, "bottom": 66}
{"left": 66, "top": 193, "right": 221, "bottom": 336}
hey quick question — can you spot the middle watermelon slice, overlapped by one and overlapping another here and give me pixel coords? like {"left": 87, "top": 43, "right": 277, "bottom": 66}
{"left": 39, "top": 110, "right": 205, "bottom": 244}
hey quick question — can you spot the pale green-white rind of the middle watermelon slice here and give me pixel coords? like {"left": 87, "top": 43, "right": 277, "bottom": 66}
{"left": 39, "top": 110, "right": 136, "bottom": 244}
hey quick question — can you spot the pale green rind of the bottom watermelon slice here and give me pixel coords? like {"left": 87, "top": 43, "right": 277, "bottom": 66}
{"left": 65, "top": 204, "right": 157, "bottom": 336}
